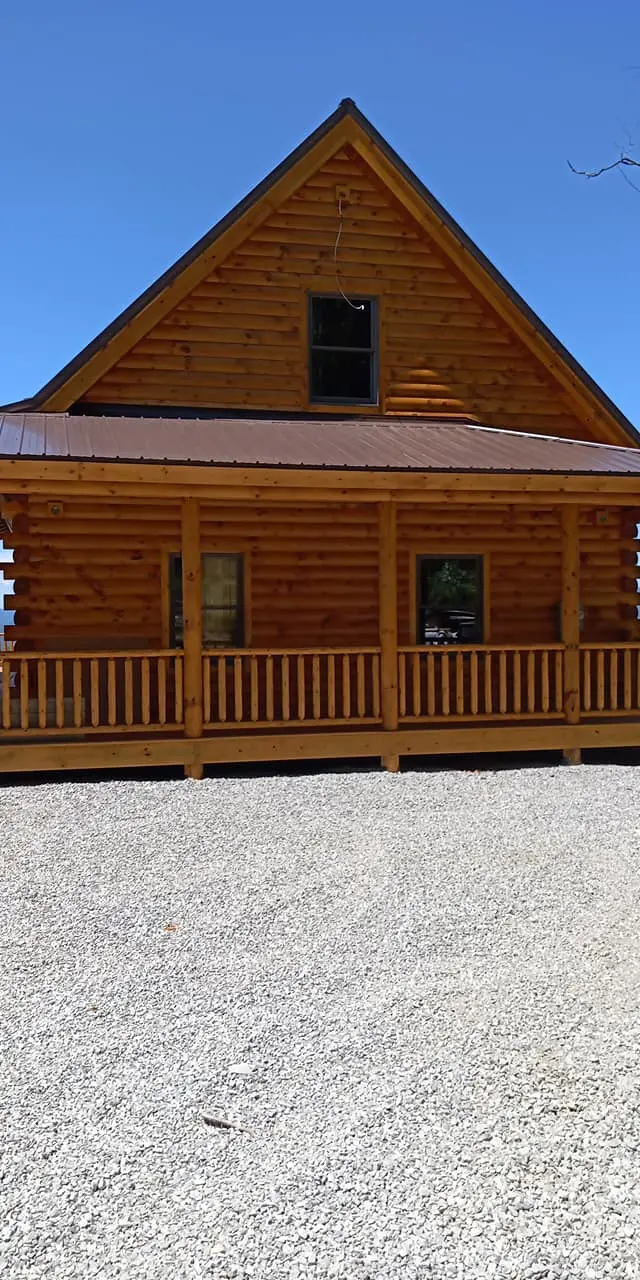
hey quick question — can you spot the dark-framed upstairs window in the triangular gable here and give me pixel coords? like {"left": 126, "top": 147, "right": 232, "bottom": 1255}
{"left": 308, "top": 293, "right": 378, "bottom": 404}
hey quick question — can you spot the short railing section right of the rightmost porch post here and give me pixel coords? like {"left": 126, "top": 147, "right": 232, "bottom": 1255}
{"left": 580, "top": 643, "right": 640, "bottom": 717}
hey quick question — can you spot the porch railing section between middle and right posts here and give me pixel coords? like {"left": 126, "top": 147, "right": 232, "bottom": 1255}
{"left": 398, "top": 644, "right": 564, "bottom": 722}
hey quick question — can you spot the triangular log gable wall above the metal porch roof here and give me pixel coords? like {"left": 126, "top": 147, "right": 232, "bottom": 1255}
{"left": 22, "top": 104, "right": 635, "bottom": 444}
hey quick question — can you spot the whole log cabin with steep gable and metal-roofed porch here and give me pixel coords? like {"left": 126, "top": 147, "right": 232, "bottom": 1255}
{"left": 0, "top": 100, "right": 640, "bottom": 778}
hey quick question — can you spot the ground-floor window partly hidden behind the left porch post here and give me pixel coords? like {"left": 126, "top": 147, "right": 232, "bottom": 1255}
{"left": 169, "top": 552, "right": 244, "bottom": 649}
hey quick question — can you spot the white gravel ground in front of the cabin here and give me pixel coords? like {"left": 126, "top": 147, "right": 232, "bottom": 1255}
{"left": 0, "top": 765, "right": 640, "bottom": 1280}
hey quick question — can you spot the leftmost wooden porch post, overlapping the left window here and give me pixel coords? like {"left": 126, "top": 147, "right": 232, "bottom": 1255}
{"left": 182, "top": 498, "right": 202, "bottom": 778}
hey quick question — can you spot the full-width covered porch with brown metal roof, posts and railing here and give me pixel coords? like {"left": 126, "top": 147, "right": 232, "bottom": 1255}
{"left": 0, "top": 413, "right": 640, "bottom": 777}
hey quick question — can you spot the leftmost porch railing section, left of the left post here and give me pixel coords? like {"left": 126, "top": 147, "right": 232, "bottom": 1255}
{"left": 0, "top": 649, "right": 184, "bottom": 737}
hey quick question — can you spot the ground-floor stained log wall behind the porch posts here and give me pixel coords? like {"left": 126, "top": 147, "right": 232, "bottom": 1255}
{"left": 5, "top": 498, "right": 624, "bottom": 650}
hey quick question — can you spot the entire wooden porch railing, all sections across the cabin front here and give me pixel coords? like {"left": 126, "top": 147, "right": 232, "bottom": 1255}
{"left": 0, "top": 643, "right": 640, "bottom": 737}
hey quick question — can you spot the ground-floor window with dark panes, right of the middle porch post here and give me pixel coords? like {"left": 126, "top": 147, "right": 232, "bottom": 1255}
{"left": 416, "top": 556, "right": 484, "bottom": 644}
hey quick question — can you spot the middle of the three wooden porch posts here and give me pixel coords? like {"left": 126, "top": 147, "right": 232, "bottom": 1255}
{"left": 378, "top": 502, "right": 399, "bottom": 773}
